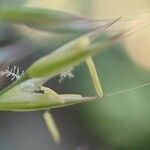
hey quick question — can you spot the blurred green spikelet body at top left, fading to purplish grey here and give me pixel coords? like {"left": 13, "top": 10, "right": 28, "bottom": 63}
{"left": 0, "top": 6, "right": 103, "bottom": 33}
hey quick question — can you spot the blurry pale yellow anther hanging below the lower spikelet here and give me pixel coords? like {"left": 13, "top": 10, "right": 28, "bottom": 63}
{"left": 43, "top": 111, "right": 61, "bottom": 143}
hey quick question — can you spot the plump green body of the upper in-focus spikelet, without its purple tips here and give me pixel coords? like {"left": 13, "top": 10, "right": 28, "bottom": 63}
{"left": 27, "top": 36, "right": 89, "bottom": 78}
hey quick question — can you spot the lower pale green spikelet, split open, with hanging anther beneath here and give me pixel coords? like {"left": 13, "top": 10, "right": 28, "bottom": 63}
{"left": 0, "top": 78, "right": 96, "bottom": 111}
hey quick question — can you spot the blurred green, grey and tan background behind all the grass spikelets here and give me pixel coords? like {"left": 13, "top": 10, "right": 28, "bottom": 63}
{"left": 0, "top": 0, "right": 150, "bottom": 150}
